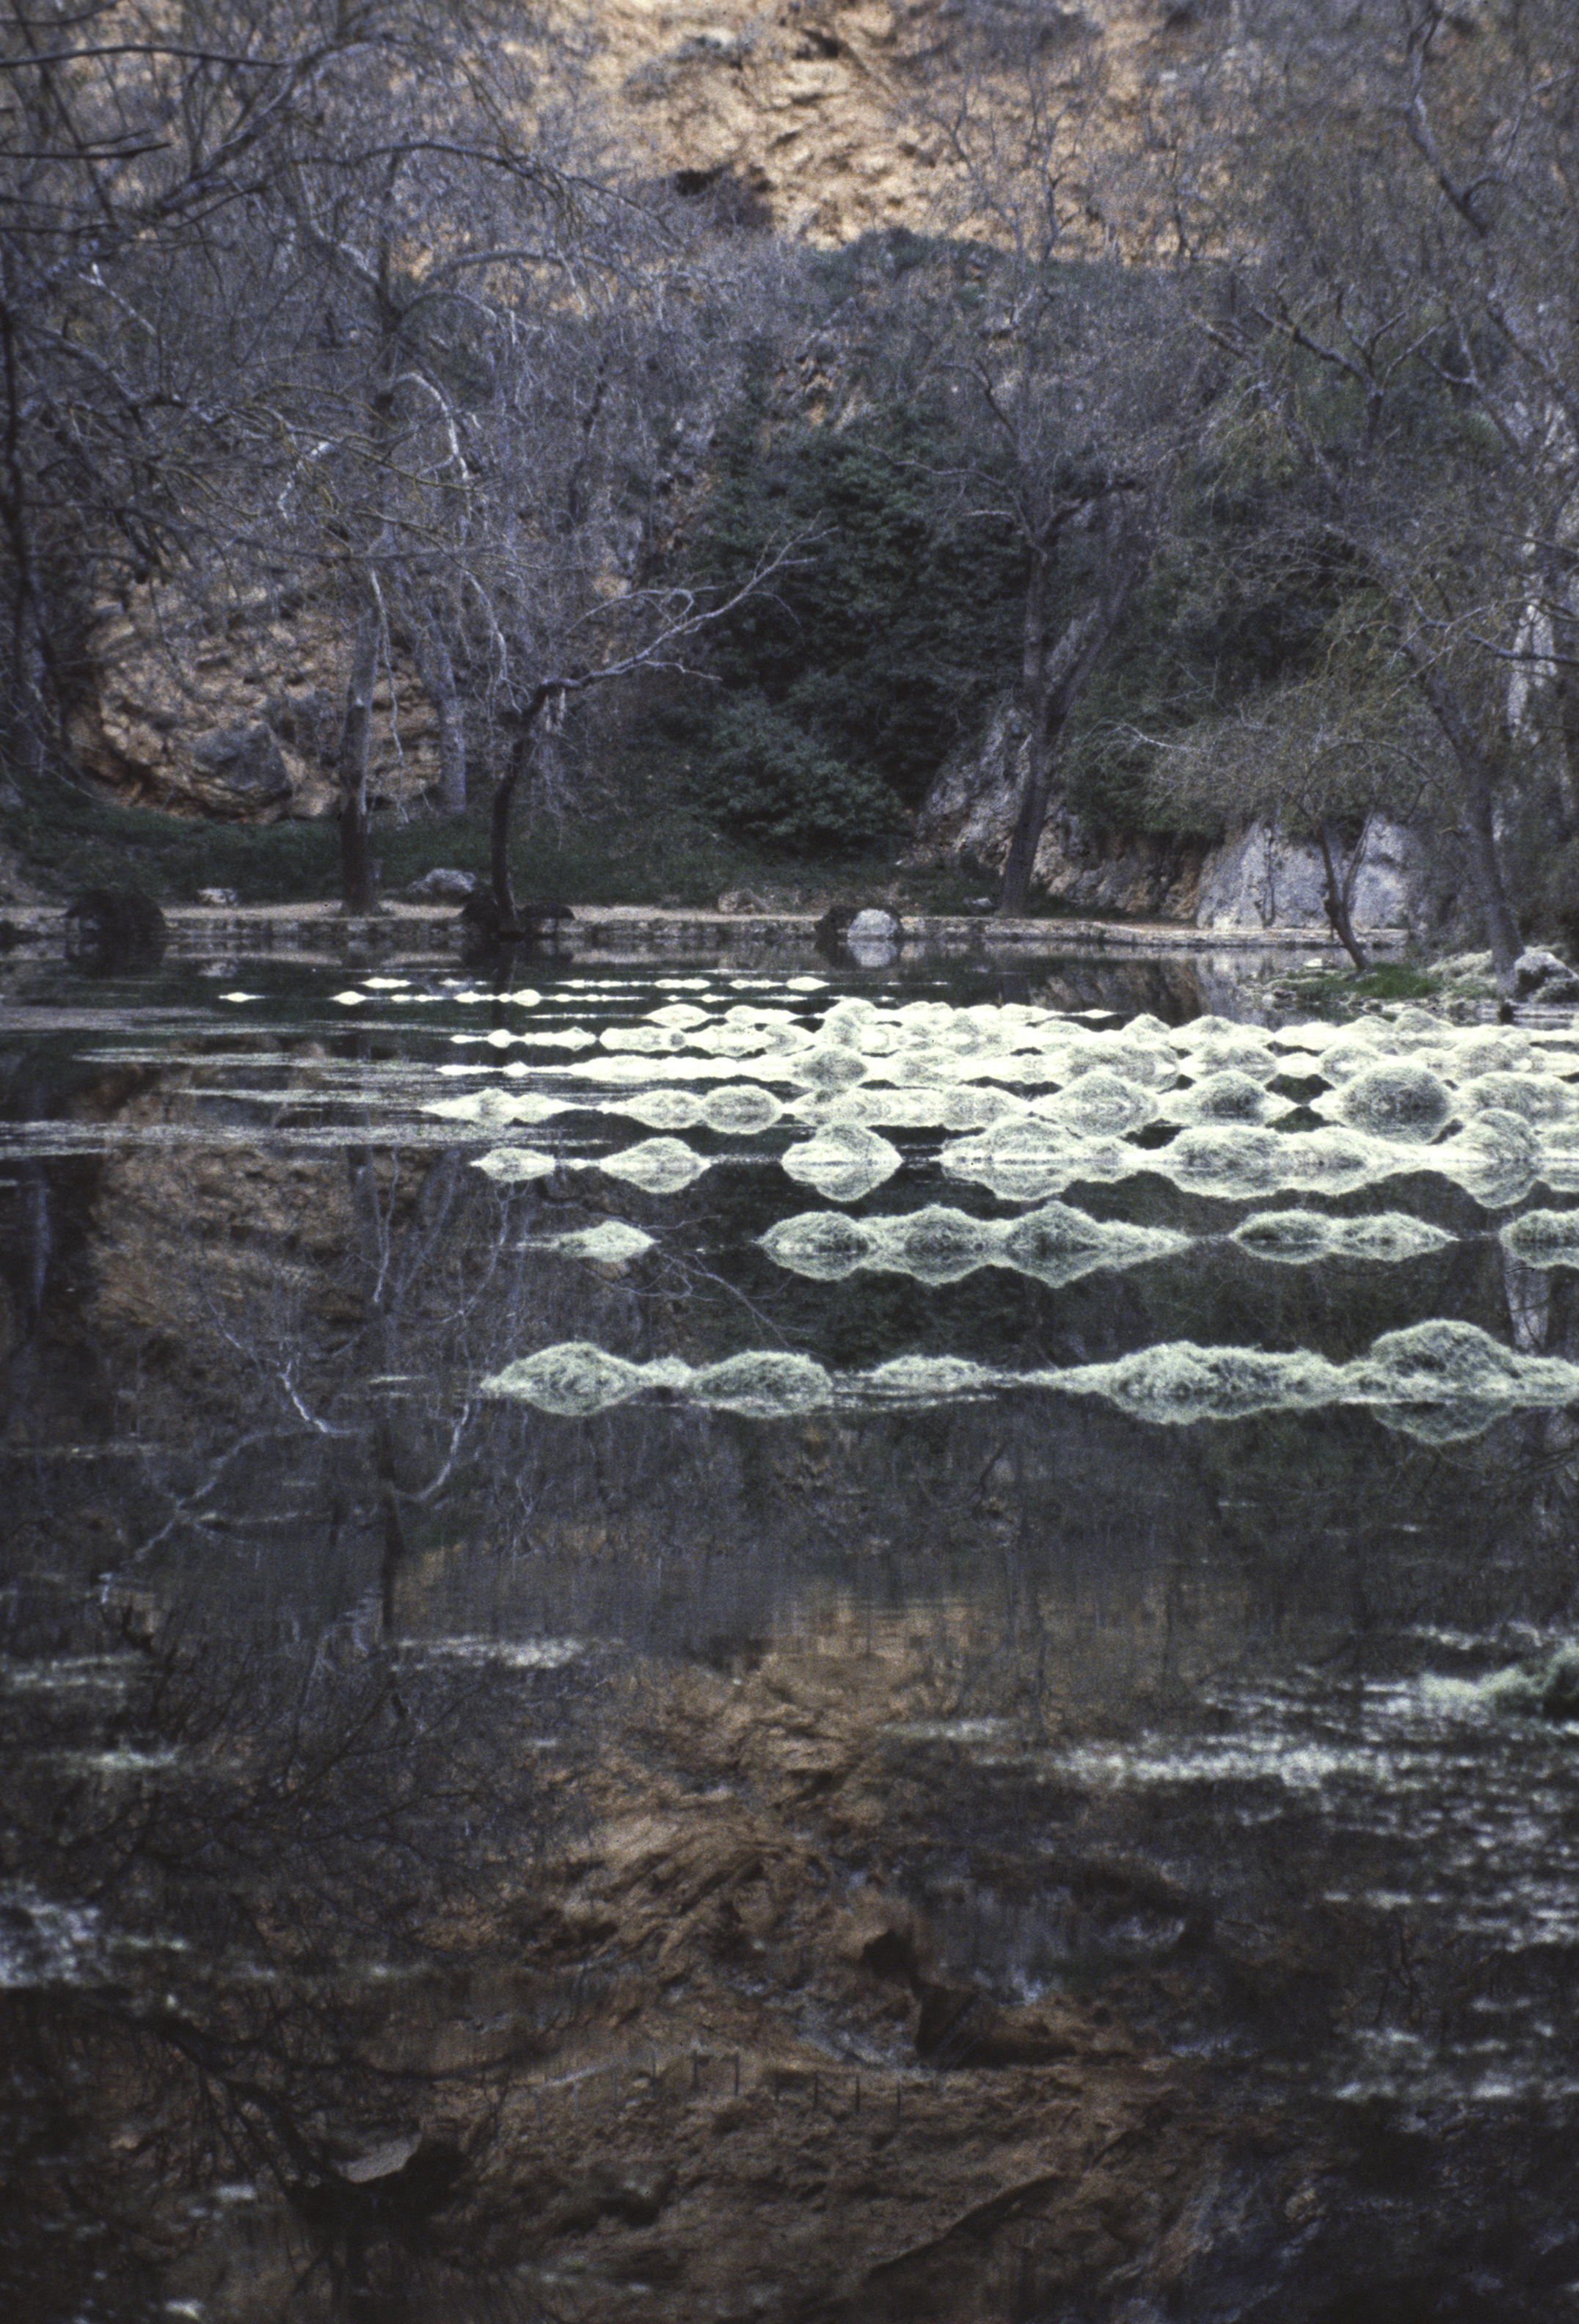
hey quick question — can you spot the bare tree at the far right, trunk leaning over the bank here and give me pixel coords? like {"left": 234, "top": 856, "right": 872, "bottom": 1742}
{"left": 1151, "top": 0, "right": 1579, "bottom": 979}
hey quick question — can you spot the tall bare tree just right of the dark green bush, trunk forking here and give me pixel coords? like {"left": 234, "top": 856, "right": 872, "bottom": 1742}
{"left": 888, "top": 26, "right": 1209, "bottom": 913}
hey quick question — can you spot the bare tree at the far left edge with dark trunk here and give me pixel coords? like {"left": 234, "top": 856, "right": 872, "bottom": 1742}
{"left": 0, "top": 0, "right": 432, "bottom": 790}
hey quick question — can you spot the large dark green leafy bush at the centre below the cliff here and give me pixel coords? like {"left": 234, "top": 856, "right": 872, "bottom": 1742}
{"left": 644, "top": 381, "right": 1021, "bottom": 850}
